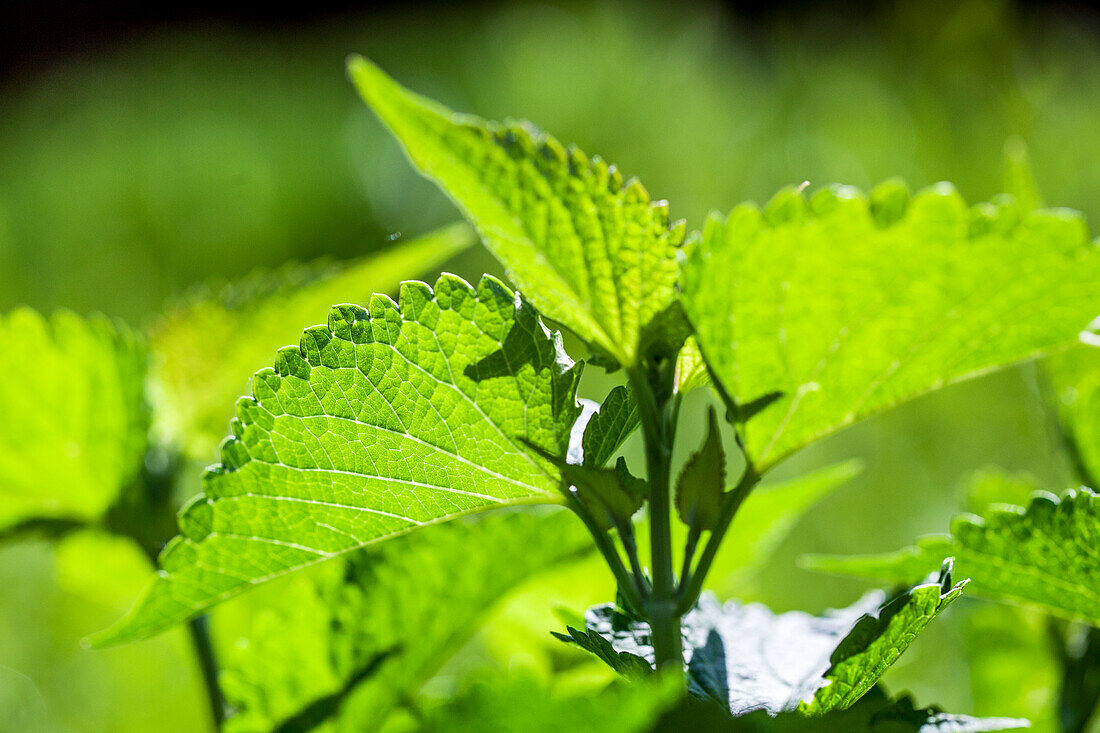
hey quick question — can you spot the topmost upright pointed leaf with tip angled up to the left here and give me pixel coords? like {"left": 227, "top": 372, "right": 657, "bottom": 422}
{"left": 348, "top": 56, "right": 684, "bottom": 367}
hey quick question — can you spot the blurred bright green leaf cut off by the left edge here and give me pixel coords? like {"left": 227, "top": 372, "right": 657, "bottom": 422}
{"left": 0, "top": 308, "right": 149, "bottom": 528}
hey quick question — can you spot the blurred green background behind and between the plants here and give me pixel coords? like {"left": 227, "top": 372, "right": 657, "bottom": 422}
{"left": 0, "top": 0, "right": 1100, "bottom": 731}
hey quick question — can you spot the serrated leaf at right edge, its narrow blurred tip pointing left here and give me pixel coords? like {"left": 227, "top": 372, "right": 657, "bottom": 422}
{"left": 804, "top": 488, "right": 1100, "bottom": 625}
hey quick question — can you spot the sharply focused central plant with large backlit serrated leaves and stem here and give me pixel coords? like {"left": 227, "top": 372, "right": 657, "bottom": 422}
{"left": 64, "top": 57, "right": 1100, "bottom": 731}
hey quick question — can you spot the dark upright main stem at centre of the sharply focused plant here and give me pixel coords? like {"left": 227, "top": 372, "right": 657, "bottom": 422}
{"left": 627, "top": 369, "right": 683, "bottom": 678}
